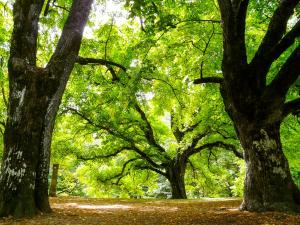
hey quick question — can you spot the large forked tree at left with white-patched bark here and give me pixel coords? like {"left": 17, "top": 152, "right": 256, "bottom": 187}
{"left": 0, "top": 0, "right": 92, "bottom": 217}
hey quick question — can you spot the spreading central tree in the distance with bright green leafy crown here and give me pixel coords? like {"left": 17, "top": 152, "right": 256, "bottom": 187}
{"left": 51, "top": 10, "right": 241, "bottom": 198}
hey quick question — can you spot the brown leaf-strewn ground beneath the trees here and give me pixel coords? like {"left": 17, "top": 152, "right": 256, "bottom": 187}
{"left": 0, "top": 197, "right": 300, "bottom": 225}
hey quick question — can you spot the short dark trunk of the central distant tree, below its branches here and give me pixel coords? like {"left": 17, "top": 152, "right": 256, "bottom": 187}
{"left": 167, "top": 159, "right": 187, "bottom": 199}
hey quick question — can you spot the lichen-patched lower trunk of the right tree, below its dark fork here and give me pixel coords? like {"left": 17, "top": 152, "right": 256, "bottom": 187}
{"left": 237, "top": 121, "right": 300, "bottom": 211}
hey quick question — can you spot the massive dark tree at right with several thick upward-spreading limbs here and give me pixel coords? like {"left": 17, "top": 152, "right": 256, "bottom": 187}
{"left": 211, "top": 0, "right": 300, "bottom": 211}
